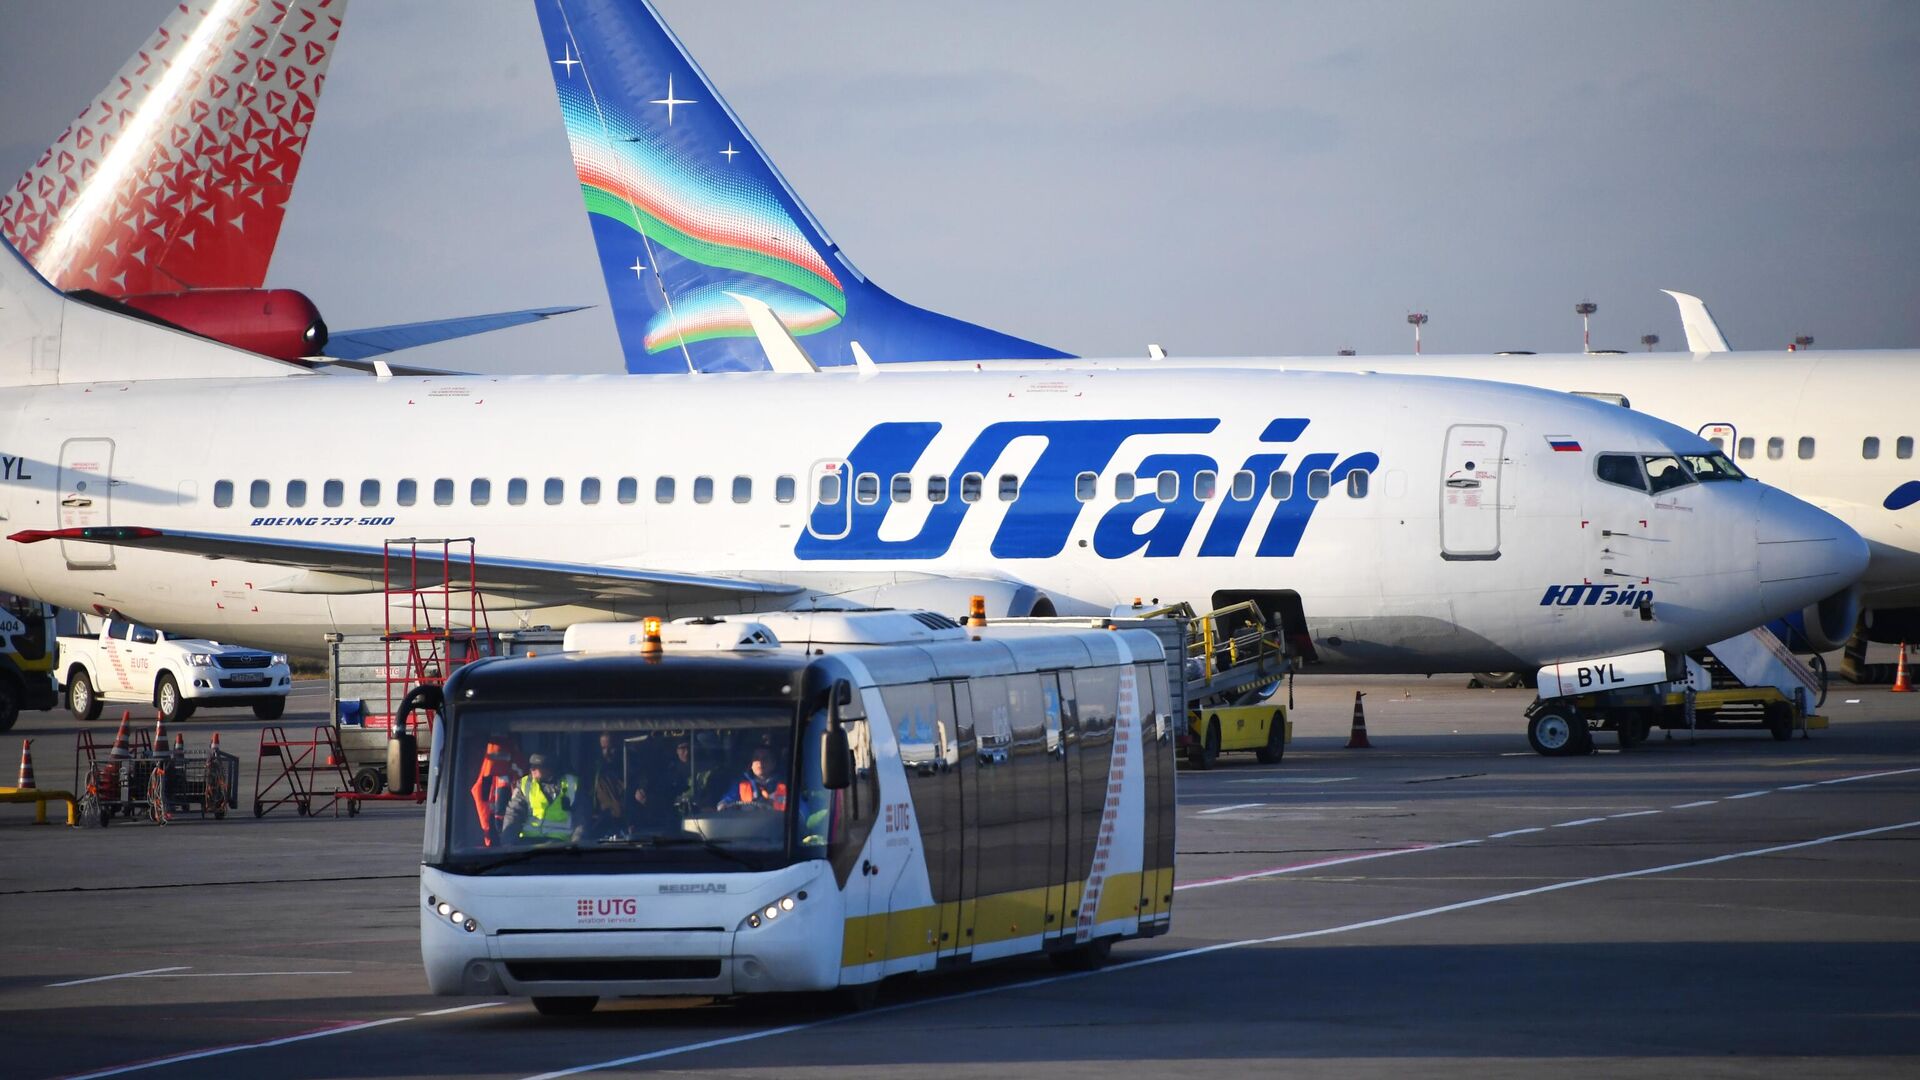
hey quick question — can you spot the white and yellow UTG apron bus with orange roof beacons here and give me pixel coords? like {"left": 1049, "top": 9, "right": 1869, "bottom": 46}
{"left": 412, "top": 611, "right": 1175, "bottom": 1015}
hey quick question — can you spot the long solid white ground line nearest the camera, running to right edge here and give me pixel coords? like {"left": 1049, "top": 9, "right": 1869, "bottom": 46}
{"left": 528, "top": 821, "right": 1920, "bottom": 1080}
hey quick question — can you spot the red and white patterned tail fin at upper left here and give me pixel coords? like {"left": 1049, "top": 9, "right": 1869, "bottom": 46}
{"left": 0, "top": 0, "right": 348, "bottom": 296}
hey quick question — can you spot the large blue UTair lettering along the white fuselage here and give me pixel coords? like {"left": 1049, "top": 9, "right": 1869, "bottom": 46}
{"left": 795, "top": 417, "right": 1380, "bottom": 559}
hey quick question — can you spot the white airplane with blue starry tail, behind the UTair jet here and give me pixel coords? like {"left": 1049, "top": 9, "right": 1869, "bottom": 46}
{"left": 538, "top": 0, "right": 1920, "bottom": 650}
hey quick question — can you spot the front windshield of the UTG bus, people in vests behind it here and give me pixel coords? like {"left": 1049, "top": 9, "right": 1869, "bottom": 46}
{"left": 428, "top": 703, "right": 828, "bottom": 874}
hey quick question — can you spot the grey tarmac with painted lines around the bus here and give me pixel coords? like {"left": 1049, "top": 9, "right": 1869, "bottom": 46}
{"left": 0, "top": 676, "right": 1920, "bottom": 1080}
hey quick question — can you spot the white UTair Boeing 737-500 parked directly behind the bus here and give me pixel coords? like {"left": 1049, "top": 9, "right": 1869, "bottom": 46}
{"left": 0, "top": 240, "right": 1866, "bottom": 673}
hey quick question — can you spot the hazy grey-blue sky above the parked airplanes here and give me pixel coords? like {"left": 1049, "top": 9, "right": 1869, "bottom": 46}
{"left": 0, "top": 0, "right": 1920, "bottom": 371}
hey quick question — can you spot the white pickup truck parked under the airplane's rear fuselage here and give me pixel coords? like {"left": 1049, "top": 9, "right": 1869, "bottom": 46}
{"left": 60, "top": 619, "right": 294, "bottom": 723}
